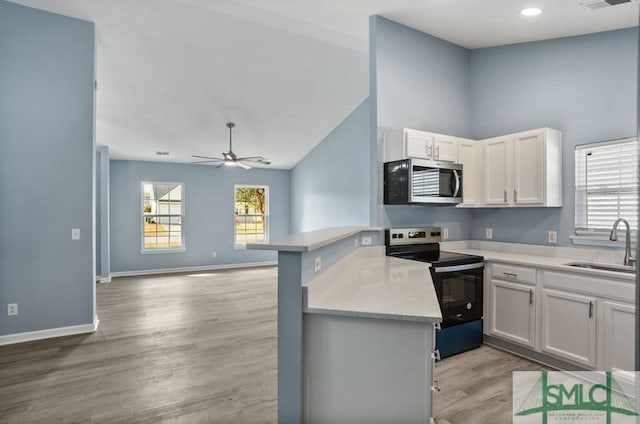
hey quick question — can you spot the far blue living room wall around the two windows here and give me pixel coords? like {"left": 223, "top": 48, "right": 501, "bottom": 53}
{"left": 110, "top": 160, "right": 290, "bottom": 273}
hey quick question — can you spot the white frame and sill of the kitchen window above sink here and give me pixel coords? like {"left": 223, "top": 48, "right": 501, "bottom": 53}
{"left": 570, "top": 137, "right": 640, "bottom": 248}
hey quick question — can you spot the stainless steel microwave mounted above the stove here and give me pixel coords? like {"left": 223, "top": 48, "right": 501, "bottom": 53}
{"left": 384, "top": 159, "right": 462, "bottom": 205}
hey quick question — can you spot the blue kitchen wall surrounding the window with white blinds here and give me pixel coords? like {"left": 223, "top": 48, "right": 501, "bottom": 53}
{"left": 470, "top": 28, "right": 638, "bottom": 246}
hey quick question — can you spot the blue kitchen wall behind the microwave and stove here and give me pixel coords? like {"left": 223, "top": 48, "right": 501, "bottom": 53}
{"left": 370, "top": 16, "right": 471, "bottom": 240}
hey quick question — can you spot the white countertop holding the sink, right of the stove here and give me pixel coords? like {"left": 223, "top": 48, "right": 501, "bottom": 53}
{"left": 442, "top": 248, "right": 636, "bottom": 282}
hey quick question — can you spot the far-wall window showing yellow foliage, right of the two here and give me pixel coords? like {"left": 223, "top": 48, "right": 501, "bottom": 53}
{"left": 235, "top": 185, "right": 269, "bottom": 247}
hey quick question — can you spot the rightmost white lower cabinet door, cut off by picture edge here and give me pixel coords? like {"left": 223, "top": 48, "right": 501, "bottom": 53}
{"left": 603, "top": 301, "right": 636, "bottom": 371}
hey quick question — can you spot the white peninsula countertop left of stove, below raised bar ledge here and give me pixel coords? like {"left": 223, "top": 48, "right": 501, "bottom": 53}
{"left": 303, "top": 246, "right": 442, "bottom": 323}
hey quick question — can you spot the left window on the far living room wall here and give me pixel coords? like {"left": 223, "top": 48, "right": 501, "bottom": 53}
{"left": 142, "top": 182, "right": 184, "bottom": 251}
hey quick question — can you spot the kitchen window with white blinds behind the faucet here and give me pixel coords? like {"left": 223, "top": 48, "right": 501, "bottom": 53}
{"left": 574, "top": 138, "right": 638, "bottom": 241}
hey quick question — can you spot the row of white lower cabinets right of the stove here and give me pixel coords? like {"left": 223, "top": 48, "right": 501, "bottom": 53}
{"left": 484, "top": 261, "right": 636, "bottom": 371}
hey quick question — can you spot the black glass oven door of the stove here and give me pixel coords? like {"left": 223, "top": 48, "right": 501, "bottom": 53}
{"left": 431, "top": 262, "right": 484, "bottom": 328}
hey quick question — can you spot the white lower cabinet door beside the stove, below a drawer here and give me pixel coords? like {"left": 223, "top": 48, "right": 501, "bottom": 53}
{"left": 489, "top": 280, "right": 536, "bottom": 347}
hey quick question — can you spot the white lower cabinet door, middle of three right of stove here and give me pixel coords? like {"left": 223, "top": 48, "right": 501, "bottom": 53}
{"left": 542, "top": 289, "right": 596, "bottom": 368}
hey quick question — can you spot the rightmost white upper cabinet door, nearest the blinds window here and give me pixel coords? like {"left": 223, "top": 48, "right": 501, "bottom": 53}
{"left": 513, "top": 131, "right": 545, "bottom": 205}
